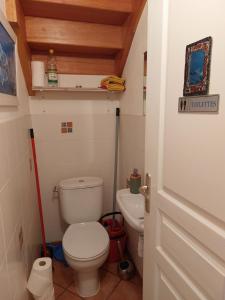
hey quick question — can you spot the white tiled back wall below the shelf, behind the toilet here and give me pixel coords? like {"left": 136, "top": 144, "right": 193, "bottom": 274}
{"left": 32, "top": 110, "right": 118, "bottom": 241}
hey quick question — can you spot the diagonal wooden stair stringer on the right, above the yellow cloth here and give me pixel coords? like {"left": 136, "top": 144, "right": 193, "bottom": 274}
{"left": 116, "top": 0, "right": 147, "bottom": 76}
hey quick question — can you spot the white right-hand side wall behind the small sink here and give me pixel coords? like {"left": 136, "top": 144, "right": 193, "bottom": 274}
{"left": 119, "top": 5, "right": 147, "bottom": 274}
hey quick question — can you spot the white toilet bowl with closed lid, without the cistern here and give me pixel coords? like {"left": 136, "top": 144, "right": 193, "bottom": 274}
{"left": 63, "top": 222, "right": 109, "bottom": 297}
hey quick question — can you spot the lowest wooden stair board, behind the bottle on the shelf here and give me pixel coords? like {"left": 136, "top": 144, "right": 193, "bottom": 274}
{"left": 32, "top": 54, "right": 115, "bottom": 75}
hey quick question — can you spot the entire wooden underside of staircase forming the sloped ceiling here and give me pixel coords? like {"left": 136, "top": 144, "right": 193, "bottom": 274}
{"left": 6, "top": 0, "right": 146, "bottom": 94}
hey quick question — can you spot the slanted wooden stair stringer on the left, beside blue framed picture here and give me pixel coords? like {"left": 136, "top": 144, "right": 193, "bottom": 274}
{"left": 6, "top": 0, "right": 34, "bottom": 95}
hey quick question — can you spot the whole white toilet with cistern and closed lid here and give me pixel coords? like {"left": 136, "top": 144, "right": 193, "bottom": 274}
{"left": 59, "top": 177, "right": 109, "bottom": 297}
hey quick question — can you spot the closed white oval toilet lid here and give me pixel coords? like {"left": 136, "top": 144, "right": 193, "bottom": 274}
{"left": 63, "top": 222, "right": 109, "bottom": 260}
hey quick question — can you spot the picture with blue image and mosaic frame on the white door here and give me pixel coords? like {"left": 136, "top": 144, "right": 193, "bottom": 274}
{"left": 183, "top": 37, "right": 212, "bottom": 96}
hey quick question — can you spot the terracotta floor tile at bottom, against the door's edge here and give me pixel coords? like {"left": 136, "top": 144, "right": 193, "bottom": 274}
{"left": 108, "top": 281, "right": 142, "bottom": 300}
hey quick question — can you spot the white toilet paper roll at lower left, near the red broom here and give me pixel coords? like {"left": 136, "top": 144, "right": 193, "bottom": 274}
{"left": 27, "top": 257, "right": 53, "bottom": 297}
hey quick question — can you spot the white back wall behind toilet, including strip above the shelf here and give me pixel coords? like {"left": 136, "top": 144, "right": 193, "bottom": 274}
{"left": 30, "top": 75, "right": 119, "bottom": 241}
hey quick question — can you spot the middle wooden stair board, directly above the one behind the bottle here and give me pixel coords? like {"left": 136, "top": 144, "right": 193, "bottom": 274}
{"left": 25, "top": 17, "right": 123, "bottom": 53}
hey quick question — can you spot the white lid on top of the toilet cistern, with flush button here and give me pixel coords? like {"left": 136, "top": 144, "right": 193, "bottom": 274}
{"left": 59, "top": 177, "right": 103, "bottom": 190}
